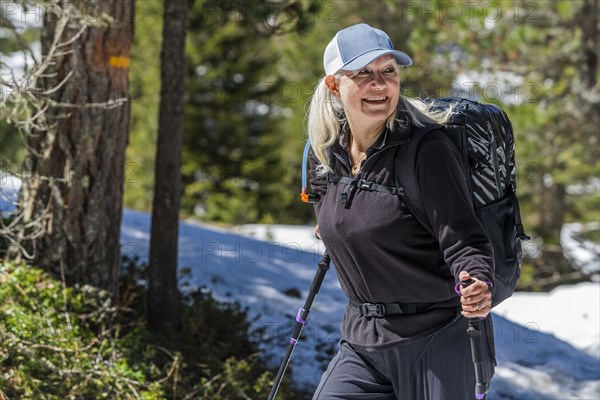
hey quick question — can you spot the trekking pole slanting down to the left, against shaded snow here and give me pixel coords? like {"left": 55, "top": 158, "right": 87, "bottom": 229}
{"left": 267, "top": 252, "right": 331, "bottom": 400}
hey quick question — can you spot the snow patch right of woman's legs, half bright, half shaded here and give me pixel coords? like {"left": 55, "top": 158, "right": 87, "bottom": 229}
{"left": 490, "top": 292, "right": 600, "bottom": 400}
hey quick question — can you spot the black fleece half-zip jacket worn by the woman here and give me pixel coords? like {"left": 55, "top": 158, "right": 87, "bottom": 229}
{"left": 310, "top": 119, "right": 494, "bottom": 348}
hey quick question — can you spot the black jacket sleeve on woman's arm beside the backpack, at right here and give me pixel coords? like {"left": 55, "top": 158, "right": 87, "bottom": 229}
{"left": 416, "top": 131, "right": 494, "bottom": 288}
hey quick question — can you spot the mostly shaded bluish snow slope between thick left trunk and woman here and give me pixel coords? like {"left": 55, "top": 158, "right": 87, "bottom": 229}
{"left": 121, "top": 210, "right": 347, "bottom": 385}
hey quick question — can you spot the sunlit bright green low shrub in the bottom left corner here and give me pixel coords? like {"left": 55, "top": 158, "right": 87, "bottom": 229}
{"left": 0, "top": 262, "right": 164, "bottom": 400}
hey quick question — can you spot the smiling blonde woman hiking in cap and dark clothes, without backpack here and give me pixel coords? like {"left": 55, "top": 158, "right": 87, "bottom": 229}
{"left": 307, "top": 24, "right": 495, "bottom": 400}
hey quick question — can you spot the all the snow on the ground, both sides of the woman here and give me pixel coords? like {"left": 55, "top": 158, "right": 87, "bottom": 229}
{"left": 0, "top": 175, "right": 600, "bottom": 400}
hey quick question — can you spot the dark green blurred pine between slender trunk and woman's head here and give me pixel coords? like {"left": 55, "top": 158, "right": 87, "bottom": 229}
{"left": 183, "top": 1, "right": 318, "bottom": 223}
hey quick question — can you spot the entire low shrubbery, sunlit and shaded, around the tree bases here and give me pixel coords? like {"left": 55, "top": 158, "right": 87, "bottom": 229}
{"left": 0, "top": 260, "right": 308, "bottom": 400}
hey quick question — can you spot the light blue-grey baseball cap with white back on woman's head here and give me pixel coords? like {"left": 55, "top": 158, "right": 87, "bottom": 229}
{"left": 323, "top": 24, "right": 412, "bottom": 75}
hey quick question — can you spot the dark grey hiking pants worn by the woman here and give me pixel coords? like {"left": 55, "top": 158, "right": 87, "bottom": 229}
{"left": 313, "top": 316, "right": 495, "bottom": 400}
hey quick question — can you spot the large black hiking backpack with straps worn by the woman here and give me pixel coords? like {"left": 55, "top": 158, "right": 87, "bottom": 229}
{"left": 302, "top": 98, "right": 530, "bottom": 306}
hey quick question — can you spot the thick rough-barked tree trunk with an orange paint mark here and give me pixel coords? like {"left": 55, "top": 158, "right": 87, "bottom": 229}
{"left": 22, "top": 0, "right": 135, "bottom": 299}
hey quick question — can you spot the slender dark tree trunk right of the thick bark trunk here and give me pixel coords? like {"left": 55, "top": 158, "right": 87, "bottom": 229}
{"left": 148, "top": 0, "right": 187, "bottom": 336}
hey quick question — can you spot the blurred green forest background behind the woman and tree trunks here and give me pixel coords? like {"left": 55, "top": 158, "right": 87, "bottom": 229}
{"left": 0, "top": 0, "right": 600, "bottom": 400}
